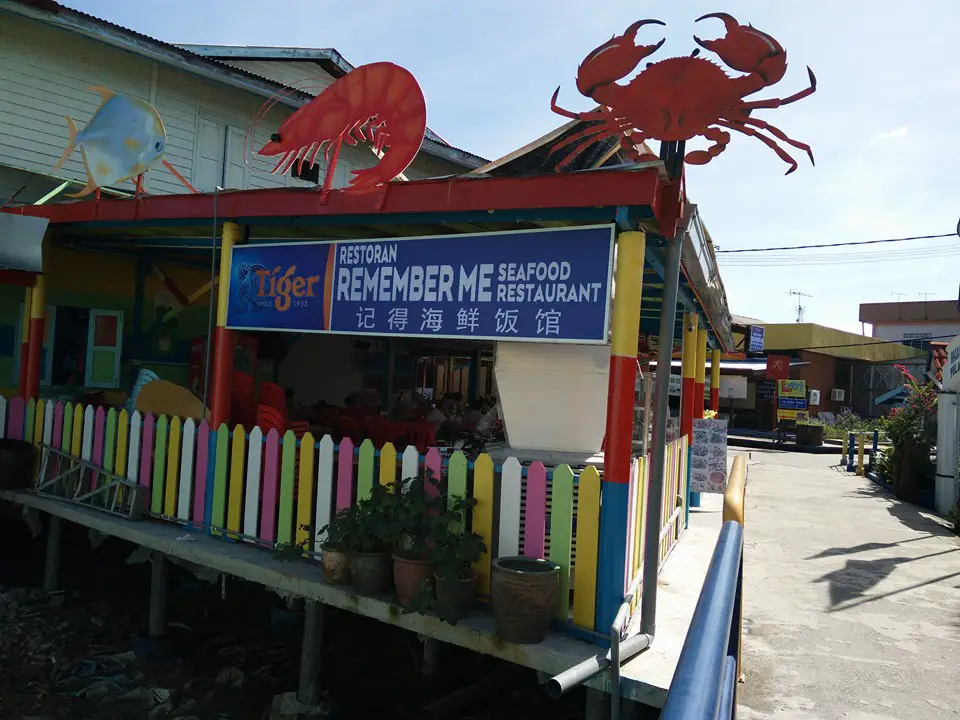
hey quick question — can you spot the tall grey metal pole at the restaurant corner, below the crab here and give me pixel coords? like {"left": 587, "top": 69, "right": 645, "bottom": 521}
{"left": 640, "top": 229, "right": 684, "bottom": 642}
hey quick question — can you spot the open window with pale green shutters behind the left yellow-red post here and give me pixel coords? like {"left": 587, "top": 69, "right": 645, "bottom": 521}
{"left": 13, "top": 304, "right": 123, "bottom": 389}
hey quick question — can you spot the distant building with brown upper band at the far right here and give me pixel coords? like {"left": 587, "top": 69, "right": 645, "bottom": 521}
{"left": 860, "top": 300, "right": 960, "bottom": 350}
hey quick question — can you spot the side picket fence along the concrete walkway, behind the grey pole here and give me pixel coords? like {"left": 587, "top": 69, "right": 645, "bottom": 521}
{"left": 623, "top": 436, "right": 689, "bottom": 613}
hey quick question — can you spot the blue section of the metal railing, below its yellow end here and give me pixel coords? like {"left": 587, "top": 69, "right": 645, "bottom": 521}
{"left": 660, "top": 521, "right": 743, "bottom": 720}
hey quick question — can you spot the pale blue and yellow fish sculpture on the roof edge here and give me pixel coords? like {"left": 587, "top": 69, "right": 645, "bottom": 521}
{"left": 53, "top": 86, "right": 197, "bottom": 197}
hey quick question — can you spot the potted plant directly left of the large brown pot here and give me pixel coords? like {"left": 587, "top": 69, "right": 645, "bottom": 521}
{"left": 432, "top": 498, "right": 487, "bottom": 625}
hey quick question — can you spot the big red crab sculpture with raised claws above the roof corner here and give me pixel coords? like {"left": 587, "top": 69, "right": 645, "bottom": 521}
{"left": 550, "top": 13, "right": 817, "bottom": 175}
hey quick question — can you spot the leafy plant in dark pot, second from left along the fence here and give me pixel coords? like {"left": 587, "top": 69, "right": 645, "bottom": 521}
{"left": 349, "top": 484, "right": 393, "bottom": 595}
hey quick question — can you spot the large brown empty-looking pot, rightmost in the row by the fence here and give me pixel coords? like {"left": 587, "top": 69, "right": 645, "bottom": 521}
{"left": 490, "top": 556, "right": 560, "bottom": 644}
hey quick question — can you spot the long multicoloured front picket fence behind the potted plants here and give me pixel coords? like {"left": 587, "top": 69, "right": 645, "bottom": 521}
{"left": 0, "top": 398, "right": 600, "bottom": 631}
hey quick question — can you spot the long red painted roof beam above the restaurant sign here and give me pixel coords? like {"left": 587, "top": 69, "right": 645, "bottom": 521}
{"left": 5, "top": 169, "right": 660, "bottom": 224}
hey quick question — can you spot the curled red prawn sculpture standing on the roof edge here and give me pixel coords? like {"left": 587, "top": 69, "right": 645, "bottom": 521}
{"left": 258, "top": 62, "right": 427, "bottom": 196}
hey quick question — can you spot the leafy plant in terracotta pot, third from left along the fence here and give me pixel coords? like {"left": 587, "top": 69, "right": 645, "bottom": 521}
{"left": 390, "top": 468, "right": 443, "bottom": 607}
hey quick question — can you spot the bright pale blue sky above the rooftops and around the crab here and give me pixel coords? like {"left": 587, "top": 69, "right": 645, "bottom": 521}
{"left": 64, "top": 0, "right": 960, "bottom": 333}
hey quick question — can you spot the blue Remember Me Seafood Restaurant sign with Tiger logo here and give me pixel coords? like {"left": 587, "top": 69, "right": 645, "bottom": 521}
{"left": 227, "top": 225, "right": 614, "bottom": 343}
